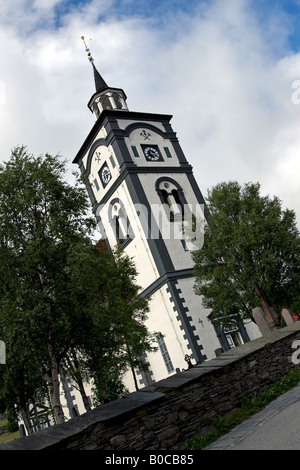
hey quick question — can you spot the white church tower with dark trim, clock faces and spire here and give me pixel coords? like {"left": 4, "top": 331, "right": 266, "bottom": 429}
{"left": 73, "top": 38, "right": 258, "bottom": 387}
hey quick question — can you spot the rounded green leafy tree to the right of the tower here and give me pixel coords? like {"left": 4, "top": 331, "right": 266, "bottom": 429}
{"left": 193, "top": 181, "right": 300, "bottom": 326}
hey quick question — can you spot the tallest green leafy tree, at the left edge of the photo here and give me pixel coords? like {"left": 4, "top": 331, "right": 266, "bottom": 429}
{"left": 0, "top": 147, "right": 92, "bottom": 423}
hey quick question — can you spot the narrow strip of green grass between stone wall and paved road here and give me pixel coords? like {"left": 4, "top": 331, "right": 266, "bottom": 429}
{"left": 184, "top": 367, "right": 300, "bottom": 450}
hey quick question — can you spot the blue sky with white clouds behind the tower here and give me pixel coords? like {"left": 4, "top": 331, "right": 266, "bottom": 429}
{"left": 0, "top": 0, "right": 300, "bottom": 224}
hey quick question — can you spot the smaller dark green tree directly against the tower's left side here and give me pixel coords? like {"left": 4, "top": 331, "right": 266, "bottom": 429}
{"left": 68, "top": 242, "right": 155, "bottom": 403}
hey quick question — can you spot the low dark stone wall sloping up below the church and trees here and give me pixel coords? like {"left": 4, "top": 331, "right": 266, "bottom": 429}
{"left": 0, "top": 322, "right": 300, "bottom": 450}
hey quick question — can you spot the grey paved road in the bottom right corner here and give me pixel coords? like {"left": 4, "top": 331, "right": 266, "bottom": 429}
{"left": 205, "top": 384, "right": 300, "bottom": 450}
